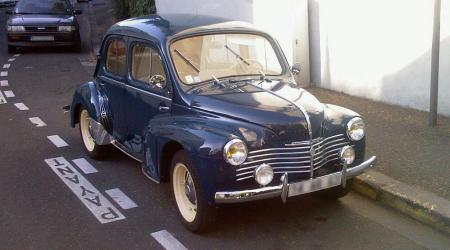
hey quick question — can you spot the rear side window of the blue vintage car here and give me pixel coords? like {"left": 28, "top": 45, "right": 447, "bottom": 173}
{"left": 106, "top": 38, "right": 127, "bottom": 76}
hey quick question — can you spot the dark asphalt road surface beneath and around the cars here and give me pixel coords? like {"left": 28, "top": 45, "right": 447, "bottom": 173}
{"left": 0, "top": 4, "right": 450, "bottom": 249}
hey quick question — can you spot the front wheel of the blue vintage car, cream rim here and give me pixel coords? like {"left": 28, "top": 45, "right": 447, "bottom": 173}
{"left": 170, "top": 150, "right": 216, "bottom": 233}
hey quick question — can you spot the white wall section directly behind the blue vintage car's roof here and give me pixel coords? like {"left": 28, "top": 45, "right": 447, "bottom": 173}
{"left": 156, "top": 0, "right": 310, "bottom": 85}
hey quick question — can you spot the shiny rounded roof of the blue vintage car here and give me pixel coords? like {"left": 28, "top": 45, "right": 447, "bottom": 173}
{"left": 106, "top": 14, "right": 268, "bottom": 44}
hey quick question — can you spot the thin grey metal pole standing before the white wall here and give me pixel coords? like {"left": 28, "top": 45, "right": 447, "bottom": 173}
{"left": 429, "top": 0, "right": 441, "bottom": 127}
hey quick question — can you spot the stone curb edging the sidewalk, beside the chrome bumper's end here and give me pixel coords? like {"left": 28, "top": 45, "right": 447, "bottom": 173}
{"left": 353, "top": 171, "right": 450, "bottom": 235}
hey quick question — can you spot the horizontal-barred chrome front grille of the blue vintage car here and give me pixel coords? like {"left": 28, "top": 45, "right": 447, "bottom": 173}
{"left": 236, "top": 134, "right": 349, "bottom": 181}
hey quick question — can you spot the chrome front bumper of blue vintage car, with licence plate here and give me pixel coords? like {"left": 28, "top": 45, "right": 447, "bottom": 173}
{"left": 215, "top": 156, "right": 377, "bottom": 204}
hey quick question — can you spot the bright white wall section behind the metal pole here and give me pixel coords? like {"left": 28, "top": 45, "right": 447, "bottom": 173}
{"left": 309, "top": 0, "right": 450, "bottom": 116}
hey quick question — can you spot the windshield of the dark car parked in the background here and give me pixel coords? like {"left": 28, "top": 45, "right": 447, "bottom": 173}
{"left": 15, "top": 0, "right": 70, "bottom": 15}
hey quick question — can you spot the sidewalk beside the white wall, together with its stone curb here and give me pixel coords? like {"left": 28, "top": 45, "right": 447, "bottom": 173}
{"left": 307, "top": 87, "right": 450, "bottom": 234}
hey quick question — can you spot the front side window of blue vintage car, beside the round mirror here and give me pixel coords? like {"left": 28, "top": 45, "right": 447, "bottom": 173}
{"left": 131, "top": 44, "right": 166, "bottom": 89}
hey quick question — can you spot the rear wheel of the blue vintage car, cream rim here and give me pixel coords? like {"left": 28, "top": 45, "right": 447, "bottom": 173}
{"left": 79, "top": 108, "right": 109, "bottom": 160}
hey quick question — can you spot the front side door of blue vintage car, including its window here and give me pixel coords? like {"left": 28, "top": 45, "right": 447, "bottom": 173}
{"left": 125, "top": 40, "right": 172, "bottom": 179}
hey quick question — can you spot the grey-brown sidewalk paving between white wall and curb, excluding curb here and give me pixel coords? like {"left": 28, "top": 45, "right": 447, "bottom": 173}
{"left": 307, "top": 87, "right": 450, "bottom": 200}
